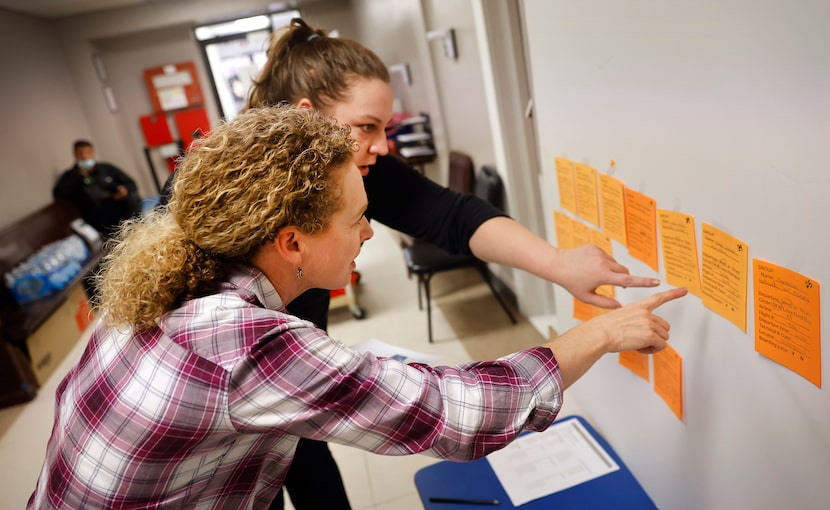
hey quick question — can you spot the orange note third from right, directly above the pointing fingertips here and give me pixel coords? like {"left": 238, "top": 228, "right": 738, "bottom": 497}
{"left": 657, "top": 209, "right": 701, "bottom": 297}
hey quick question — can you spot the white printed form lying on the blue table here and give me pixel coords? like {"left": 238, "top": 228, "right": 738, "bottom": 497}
{"left": 486, "top": 420, "right": 620, "bottom": 506}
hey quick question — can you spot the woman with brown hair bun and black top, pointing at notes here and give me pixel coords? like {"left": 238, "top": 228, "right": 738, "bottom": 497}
{"left": 248, "top": 18, "right": 659, "bottom": 510}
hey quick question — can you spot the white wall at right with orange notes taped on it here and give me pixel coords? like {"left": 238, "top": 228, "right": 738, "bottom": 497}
{"left": 522, "top": 0, "right": 830, "bottom": 510}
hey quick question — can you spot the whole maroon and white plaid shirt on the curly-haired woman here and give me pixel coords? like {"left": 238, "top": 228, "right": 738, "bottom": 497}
{"left": 29, "top": 268, "right": 562, "bottom": 509}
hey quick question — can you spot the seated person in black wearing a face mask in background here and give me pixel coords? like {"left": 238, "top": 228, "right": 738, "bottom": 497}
{"left": 52, "top": 140, "right": 141, "bottom": 238}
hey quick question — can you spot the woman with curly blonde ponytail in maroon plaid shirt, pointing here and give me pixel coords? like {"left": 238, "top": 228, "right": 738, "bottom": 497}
{"left": 28, "top": 106, "right": 685, "bottom": 510}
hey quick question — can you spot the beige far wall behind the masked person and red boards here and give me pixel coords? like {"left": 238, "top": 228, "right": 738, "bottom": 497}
{"left": 0, "top": 0, "right": 356, "bottom": 226}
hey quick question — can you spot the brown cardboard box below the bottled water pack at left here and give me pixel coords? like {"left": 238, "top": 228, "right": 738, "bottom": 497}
{"left": 26, "top": 284, "right": 92, "bottom": 386}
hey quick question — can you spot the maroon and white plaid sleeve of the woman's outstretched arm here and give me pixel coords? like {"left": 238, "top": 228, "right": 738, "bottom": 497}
{"left": 230, "top": 330, "right": 562, "bottom": 460}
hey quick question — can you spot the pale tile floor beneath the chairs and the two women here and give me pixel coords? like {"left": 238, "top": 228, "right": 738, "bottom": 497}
{"left": 0, "top": 224, "right": 579, "bottom": 510}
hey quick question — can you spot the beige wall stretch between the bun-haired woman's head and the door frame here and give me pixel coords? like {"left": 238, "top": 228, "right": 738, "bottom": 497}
{"left": 352, "top": 0, "right": 495, "bottom": 189}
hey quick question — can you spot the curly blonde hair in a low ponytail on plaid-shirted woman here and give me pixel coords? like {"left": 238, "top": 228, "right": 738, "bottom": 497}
{"left": 96, "top": 105, "right": 355, "bottom": 329}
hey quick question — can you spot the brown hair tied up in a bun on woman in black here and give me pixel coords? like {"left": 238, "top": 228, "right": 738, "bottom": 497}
{"left": 247, "top": 18, "right": 390, "bottom": 108}
